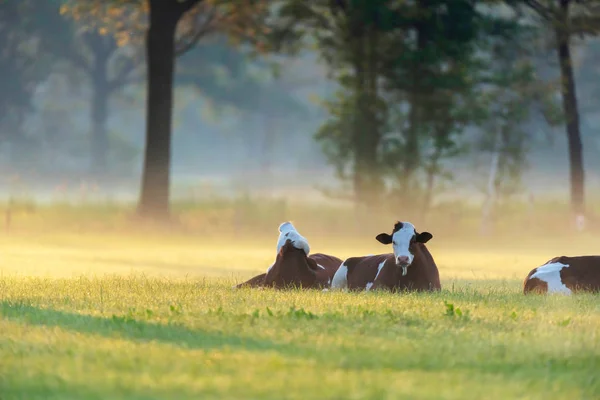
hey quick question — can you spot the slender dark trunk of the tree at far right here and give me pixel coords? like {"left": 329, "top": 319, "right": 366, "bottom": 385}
{"left": 556, "top": 0, "right": 585, "bottom": 216}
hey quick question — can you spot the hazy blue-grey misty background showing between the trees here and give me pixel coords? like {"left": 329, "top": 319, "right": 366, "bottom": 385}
{"left": 0, "top": 2, "right": 600, "bottom": 242}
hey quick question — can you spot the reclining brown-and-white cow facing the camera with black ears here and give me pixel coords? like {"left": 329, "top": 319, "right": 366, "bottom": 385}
{"left": 331, "top": 222, "right": 441, "bottom": 291}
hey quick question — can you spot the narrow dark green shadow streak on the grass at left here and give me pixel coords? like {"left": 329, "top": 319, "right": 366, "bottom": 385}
{"left": 0, "top": 301, "right": 288, "bottom": 353}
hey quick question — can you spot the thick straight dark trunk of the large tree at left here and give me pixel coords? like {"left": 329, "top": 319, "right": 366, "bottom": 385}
{"left": 138, "top": 5, "right": 181, "bottom": 219}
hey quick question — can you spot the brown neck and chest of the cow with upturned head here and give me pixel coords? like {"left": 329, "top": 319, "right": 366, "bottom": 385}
{"left": 265, "top": 239, "right": 318, "bottom": 288}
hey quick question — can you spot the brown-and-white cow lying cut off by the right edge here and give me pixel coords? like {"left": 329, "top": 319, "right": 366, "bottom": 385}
{"left": 523, "top": 256, "right": 600, "bottom": 295}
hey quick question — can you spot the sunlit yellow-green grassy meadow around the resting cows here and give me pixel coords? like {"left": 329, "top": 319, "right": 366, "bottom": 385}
{"left": 0, "top": 202, "right": 600, "bottom": 400}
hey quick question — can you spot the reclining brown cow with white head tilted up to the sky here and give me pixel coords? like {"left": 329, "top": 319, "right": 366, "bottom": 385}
{"left": 236, "top": 222, "right": 342, "bottom": 289}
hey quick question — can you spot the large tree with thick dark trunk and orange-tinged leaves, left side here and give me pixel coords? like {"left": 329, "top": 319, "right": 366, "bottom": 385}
{"left": 60, "top": 0, "right": 265, "bottom": 219}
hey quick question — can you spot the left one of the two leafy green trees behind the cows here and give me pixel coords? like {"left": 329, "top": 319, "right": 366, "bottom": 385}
{"left": 274, "top": 0, "right": 404, "bottom": 208}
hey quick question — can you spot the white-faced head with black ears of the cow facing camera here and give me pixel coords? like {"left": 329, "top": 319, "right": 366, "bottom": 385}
{"left": 375, "top": 222, "right": 433, "bottom": 275}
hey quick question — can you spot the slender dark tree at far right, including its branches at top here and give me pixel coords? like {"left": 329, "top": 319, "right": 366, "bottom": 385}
{"left": 524, "top": 0, "right": 600, "bottom": 222}
